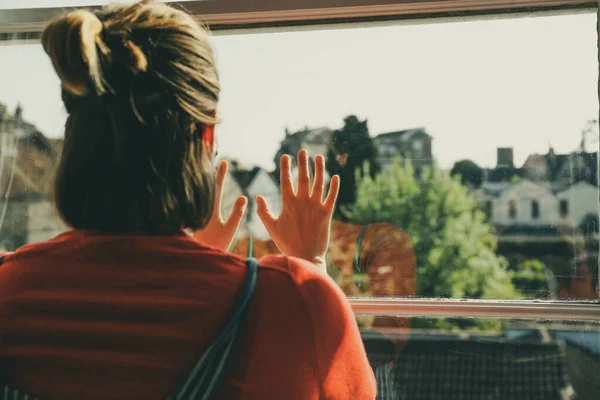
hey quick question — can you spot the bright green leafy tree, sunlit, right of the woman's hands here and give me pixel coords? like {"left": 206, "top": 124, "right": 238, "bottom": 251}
{"left": 347, "top": 160, "right": 518, "bottom": 299}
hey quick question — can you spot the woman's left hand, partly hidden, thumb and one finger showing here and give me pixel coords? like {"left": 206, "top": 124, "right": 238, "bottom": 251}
{"left": 194, "top": 160, "right": 248, "bottom": 251}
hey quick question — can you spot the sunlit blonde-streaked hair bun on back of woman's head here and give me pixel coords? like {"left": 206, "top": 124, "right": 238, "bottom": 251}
{"left": 42, "top": 10, "right": 109, "bottom": 96}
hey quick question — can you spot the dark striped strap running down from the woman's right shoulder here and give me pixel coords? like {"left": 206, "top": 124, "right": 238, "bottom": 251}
{"left": 168, "top": 258, "right": 258, "bottom": 400}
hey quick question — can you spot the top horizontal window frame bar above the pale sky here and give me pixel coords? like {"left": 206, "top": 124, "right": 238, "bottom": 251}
{"left": 0, "top": 0, "right": 598, "bottom": 34}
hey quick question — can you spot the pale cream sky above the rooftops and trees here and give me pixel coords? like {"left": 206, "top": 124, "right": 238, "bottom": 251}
{"left": 0, "top": 8, "right": 599, "bottom": 169}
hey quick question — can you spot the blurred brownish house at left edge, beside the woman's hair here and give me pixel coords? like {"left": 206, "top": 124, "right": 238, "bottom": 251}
{"left": 0, "top": 105, "right": 67, "bottom": 250}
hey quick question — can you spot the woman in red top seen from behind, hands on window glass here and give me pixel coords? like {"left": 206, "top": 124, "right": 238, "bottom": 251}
{"left": 0, "top": 1, "right": 375, "bottom": 400}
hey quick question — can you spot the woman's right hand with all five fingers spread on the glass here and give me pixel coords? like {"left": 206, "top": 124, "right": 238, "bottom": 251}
{"left": 256, "top": 150, "right": 340, "bottom": 272}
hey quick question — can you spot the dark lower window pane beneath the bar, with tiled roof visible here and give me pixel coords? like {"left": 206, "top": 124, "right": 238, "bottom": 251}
{"left": 363, "top": 318, "right": 600, "bottom": 400}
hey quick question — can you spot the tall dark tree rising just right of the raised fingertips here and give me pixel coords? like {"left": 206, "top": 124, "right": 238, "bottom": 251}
{"left": 326, "top": 115, "right": 380, "bottom": 220}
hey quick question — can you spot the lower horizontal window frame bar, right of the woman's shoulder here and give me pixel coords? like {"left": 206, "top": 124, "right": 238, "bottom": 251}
{"left": 348, "top": 298, "right": 600, "bottom": 322}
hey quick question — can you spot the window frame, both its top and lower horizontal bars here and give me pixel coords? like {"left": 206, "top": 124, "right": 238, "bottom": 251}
{"left": 0, "top": 0, "right": 600, "bottom": 321}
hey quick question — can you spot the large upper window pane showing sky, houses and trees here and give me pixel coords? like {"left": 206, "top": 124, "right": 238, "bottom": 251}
{"left": 0, "top": 10, "right": 599, "bottom": 299}
